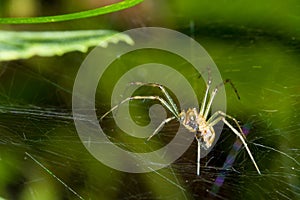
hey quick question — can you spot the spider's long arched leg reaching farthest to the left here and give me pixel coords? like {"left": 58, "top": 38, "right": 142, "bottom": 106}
{"left": 100, "top": 96, "right": 177, "bottom": 121}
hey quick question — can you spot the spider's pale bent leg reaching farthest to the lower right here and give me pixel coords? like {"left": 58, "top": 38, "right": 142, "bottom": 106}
{"left": 208, "top": 111, "right": 261, "bottom": 174}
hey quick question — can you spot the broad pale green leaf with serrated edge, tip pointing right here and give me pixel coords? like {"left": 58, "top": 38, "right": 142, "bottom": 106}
{"left": 0, "top": 30, "right": 134, "bottom": 61}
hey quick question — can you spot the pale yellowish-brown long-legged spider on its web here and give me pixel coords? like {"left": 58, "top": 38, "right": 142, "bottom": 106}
{"left": 100, "top": 79, "right": 261, "bottom": 175}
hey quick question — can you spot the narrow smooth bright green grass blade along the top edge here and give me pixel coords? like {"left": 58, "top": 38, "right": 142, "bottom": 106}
{"left": 0, "top": 0, "right": 143, "bottom": 24}
